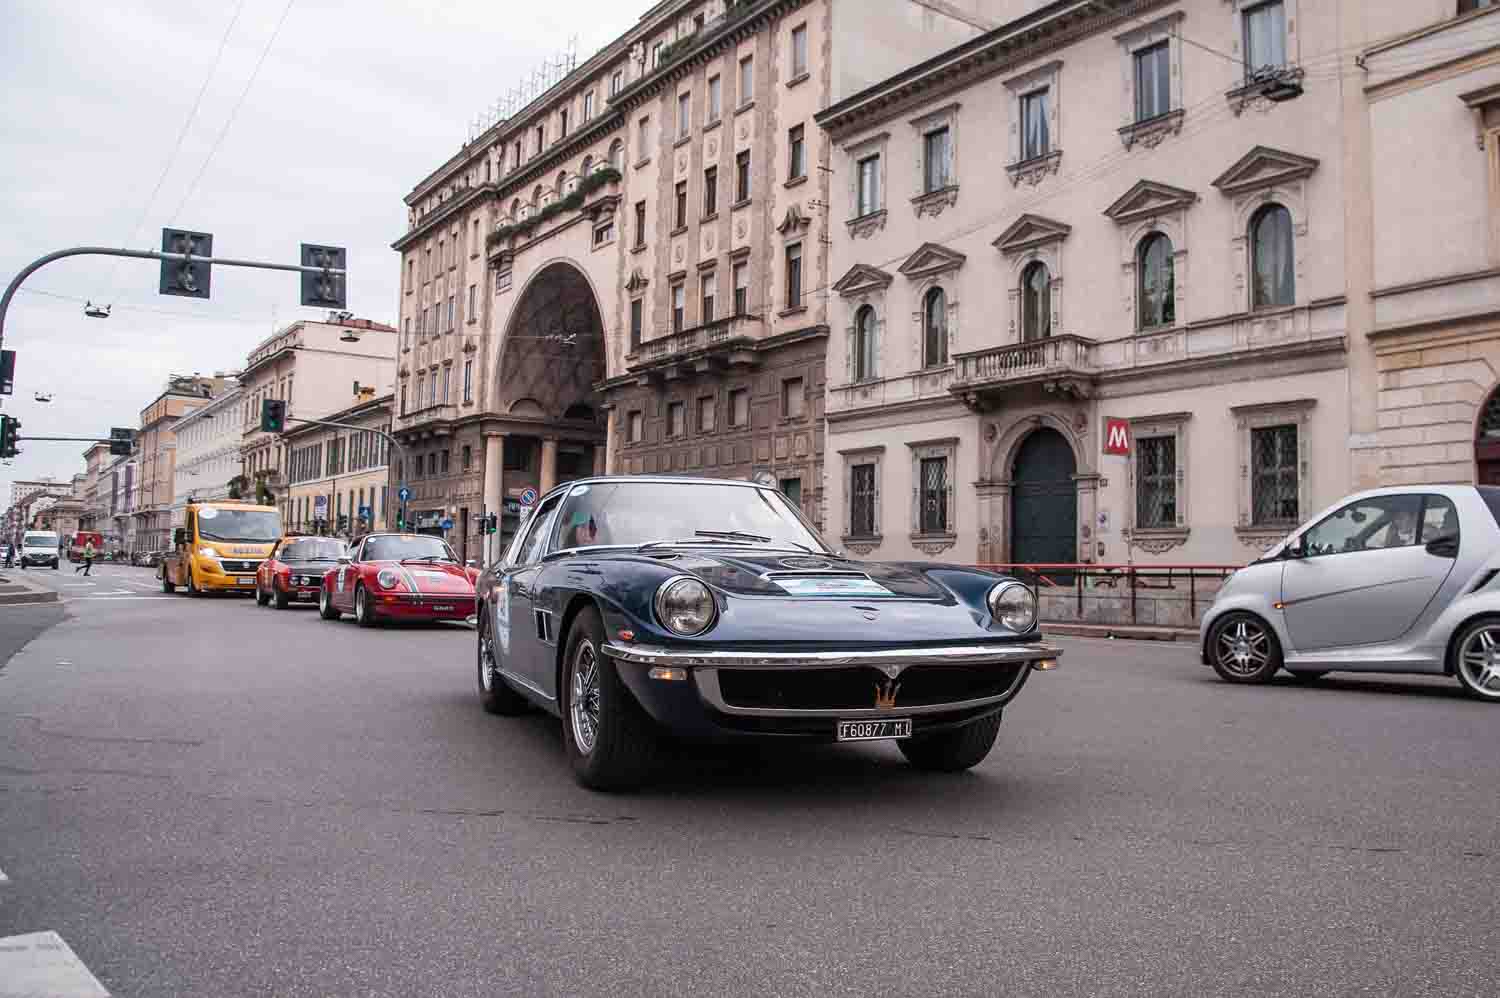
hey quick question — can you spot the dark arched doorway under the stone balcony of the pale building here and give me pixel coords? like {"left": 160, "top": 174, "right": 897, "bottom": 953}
{"left": 1011, "top": 426, "right": 1079, "bottom": 564}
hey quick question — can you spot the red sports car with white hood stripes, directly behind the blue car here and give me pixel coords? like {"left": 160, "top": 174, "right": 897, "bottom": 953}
{"left": 318, "top": 534, "right": 479, "bottom": 627}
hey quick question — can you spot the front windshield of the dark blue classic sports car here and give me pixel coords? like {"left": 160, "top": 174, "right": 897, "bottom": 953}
{"left": 555, "top": 482, "right": 828, "bottom": 551}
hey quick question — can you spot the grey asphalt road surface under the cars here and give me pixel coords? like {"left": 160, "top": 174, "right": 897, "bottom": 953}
{"left": 0, "top": 566, "right": 1500, "bottom": 998}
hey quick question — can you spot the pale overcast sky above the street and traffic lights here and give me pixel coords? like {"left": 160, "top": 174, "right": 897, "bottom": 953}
{"left": 0, "top": 0, "right": 636, "bottom": 507}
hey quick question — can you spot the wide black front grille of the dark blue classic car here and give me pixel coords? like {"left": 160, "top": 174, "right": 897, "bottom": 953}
{"left": 719, "top": 663, "right": 1025, "bottom": 710}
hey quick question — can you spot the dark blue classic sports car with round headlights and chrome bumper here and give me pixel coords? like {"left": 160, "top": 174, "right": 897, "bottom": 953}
{"left": 477, "top": 476, "right": 1059, "bottom": 789}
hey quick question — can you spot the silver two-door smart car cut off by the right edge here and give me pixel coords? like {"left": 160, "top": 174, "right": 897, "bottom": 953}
{"left": 1200, "top": 485, "right": 1500, "bottom": 702}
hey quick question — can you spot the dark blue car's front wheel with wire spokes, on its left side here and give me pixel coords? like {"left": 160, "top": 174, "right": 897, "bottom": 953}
{"left": 560, "top": 608, "right": 659, "bottom": 791}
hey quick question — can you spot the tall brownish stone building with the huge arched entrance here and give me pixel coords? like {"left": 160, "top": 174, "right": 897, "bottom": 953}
{"left": 393, "top": 0, "right": 998, "bottom": 552}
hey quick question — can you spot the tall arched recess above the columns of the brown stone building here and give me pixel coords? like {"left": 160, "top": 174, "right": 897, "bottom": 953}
{"left": 494, "top": 261, "right": 605, "bottom": 419}
